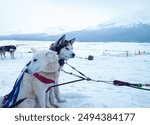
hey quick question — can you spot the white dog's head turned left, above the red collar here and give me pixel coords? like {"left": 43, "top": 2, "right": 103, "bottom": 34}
{"left": 27, "top": 48, "right": 59, "bottom": 74}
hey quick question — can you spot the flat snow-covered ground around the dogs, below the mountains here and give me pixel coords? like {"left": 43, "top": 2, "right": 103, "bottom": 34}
{"left": 0, "top": 41, "right": 150, "bottom": 108}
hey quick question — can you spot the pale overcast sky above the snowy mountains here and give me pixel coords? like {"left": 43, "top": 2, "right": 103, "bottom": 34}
{"left": 0, "top": 0, "right": 150, "bottom": 34}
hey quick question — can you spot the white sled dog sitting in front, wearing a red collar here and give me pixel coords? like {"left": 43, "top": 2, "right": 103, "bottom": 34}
{"left": 0, "top": 49, "right": 59, "bottom": 108}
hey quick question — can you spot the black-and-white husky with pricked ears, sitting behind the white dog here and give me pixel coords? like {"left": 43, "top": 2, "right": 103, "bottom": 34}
{"left": 50, "top": 35, "right": 75, "bottom": 102}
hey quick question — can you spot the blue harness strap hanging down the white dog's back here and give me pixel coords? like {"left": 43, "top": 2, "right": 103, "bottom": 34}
{"left": 2, "top": 68, "right": 26, "bottom": 108}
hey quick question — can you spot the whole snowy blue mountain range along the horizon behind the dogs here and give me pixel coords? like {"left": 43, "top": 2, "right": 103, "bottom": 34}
{"left": 0, "top": 21, "right": 150, "bottom": 42}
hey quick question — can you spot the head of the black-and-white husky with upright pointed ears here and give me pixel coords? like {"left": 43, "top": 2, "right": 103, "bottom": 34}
{"left": 50, "top": 35, "right": 75, "bottom": 60}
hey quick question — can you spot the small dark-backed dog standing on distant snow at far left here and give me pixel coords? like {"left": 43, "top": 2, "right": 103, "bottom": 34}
{"left": 2, "top": 45, "right": 16, "bottom": 59}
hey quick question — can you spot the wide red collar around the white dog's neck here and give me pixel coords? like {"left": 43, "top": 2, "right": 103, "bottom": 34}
{"left": 33, "top": 73, "right": 55, "bottom": 84}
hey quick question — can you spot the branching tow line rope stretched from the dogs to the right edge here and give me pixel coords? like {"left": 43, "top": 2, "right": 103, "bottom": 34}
{"left": 52, "top": 62, "right": 150, "bottom": 91}
